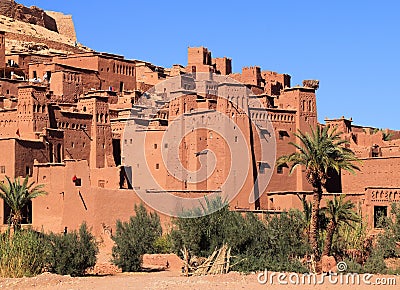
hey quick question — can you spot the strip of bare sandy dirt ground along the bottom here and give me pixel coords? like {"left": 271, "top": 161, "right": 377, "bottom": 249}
{"left": 0, "top": 271, "right": 400, "bottom": 290}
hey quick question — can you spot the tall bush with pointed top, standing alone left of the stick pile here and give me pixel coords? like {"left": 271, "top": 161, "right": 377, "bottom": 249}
{"left": 112, "top": 204, "right": 162, "bottom": 272}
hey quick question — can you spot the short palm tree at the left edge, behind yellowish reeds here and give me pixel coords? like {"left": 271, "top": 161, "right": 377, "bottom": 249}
{"left": 0, "top": 176, "right": 47, "bottom": 230}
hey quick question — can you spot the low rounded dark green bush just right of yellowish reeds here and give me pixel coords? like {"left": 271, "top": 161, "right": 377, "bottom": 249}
{"left": 47, "top": 223, "right": 99, "bottom": 276}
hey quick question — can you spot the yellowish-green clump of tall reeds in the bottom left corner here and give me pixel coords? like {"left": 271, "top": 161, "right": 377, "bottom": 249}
{"left": 0, "top": 230, "right": 46, "bottom": 278}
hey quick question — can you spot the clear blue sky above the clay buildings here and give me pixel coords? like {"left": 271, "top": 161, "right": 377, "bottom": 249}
{"left": 17, "top": 0, "right": 400, "bottom": 129}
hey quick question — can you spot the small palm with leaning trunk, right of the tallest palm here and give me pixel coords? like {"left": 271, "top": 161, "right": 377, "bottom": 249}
{"left": 321, "top": 194, "right": 360, "bottom": 256}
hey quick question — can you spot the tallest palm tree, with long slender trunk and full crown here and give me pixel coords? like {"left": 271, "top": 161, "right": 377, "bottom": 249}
{"left": 277, "top": 126, "right": 360, "bottom": 258}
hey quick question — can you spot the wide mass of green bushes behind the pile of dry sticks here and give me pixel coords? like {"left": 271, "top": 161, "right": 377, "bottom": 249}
{"left": 171, "top": 199, "right": 309, "bottom": 272}
